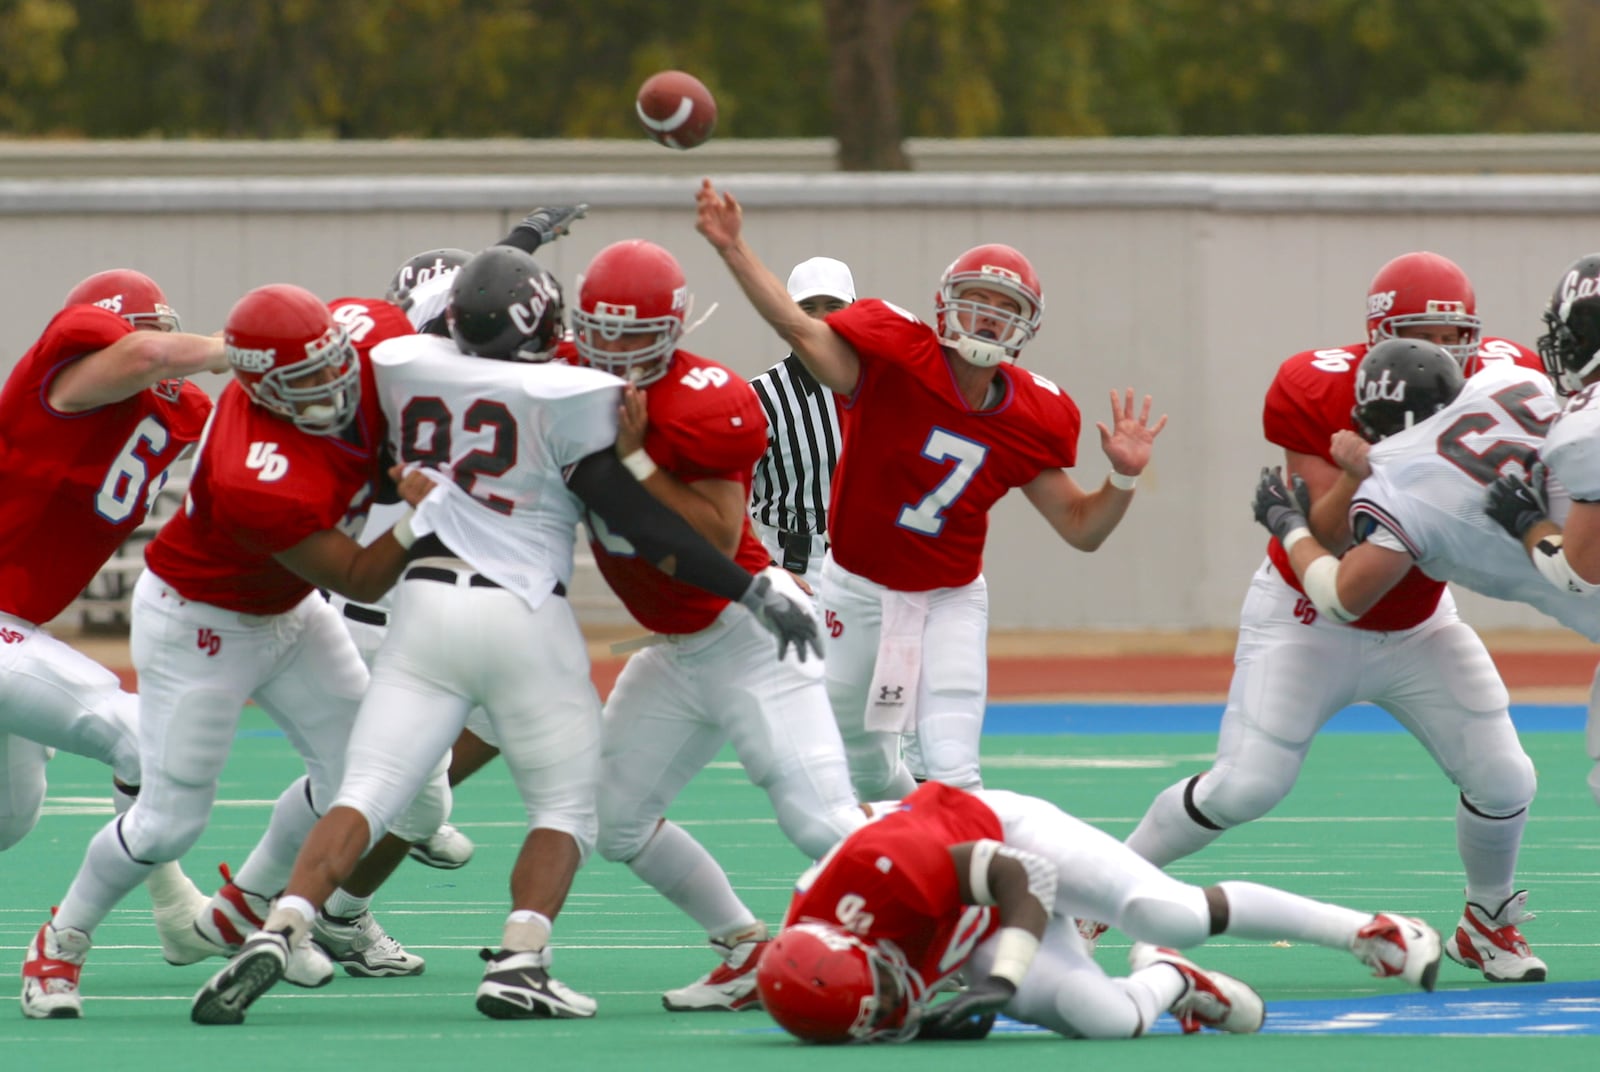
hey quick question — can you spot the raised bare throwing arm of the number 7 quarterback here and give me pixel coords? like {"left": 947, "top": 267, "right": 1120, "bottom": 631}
{"left": 694, "top": 179, "right": 861, "bottom": 395}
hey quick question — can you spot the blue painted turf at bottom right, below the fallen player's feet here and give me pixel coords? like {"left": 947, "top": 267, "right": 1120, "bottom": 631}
{"left": 995, "top": 981, "right": 1600, "bottom": 1038}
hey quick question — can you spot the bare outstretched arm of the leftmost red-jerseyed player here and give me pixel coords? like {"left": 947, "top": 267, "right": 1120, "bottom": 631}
{"left": 50, "top": 331, "right": 229, "bottom": 413}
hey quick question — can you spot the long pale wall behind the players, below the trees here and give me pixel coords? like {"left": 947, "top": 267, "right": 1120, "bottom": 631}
{"left": 12, "top": 138, "right": 1600, "bottom": 630}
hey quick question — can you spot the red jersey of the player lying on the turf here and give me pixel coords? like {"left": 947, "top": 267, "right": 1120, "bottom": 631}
{"left": 784, "top": 782, "right": 1005, "bottom": 989}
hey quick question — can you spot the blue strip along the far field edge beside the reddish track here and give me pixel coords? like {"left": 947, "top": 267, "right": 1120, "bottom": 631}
{"left": 984, "top": 702, "right": 1587, "bottom": 734}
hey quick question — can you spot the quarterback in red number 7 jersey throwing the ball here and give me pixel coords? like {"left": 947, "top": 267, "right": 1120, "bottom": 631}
{"left": 696, "top": 181, "right": 1166, "bottom": 800}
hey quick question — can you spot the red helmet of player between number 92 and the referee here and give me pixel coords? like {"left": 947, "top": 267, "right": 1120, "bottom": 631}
{"left": 573, "top": 238, "right": 693, "bottom": 387}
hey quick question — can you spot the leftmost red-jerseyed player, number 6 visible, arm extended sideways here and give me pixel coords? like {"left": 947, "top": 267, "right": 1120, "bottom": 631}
{"left": 0, "top": 269, "right": 227, "bottom": 992}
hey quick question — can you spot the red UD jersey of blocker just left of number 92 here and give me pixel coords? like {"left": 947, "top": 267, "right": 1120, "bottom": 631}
{"left": 144, "top": 299, "right": 413, "bottom": 614}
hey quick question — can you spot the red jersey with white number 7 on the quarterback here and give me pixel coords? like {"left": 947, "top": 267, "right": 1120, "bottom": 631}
{"left": 827, "top": 299, "right": 1082, "bottom": 592}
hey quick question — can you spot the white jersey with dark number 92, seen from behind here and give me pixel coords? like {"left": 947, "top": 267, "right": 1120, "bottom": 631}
{"left": 373, "top": 334, "right": 622, "bottom": 610}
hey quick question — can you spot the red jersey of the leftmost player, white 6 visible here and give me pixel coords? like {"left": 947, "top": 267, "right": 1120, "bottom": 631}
{"left": 0, "top": 306, "right": 211, "bottom": 624}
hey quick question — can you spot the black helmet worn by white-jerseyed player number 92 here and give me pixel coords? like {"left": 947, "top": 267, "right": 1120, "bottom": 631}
{"left": 445, "top": 246, "right": 565, "bottom": 362}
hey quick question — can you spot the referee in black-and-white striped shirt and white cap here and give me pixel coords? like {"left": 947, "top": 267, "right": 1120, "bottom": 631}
{"left": 750, "top": 258, "right": 856, "bottom": 576}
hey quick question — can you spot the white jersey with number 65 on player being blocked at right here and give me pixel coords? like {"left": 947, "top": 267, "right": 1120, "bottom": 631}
{"left": 1350, "top": 365, "right": 1600, "bottom": 640}
